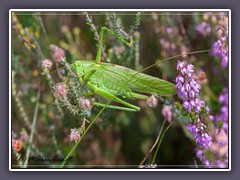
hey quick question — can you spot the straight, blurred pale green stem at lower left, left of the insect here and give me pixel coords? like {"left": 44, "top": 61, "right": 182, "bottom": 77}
{"left": 24, "top": 91, "right": 40, "bottom": 168}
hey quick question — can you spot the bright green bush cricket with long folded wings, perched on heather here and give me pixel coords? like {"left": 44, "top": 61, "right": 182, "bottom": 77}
{"left": 58, "top": 27, "right": 176, "bottom": 111}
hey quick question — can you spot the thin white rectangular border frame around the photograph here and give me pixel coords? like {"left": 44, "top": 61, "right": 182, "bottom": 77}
{"left": 9, "top": 9, "right": 232, "bottom": 171}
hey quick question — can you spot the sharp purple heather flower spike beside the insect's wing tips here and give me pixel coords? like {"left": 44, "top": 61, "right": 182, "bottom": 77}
{"left": 176, "top": 61, "right": 212, "bottom": 149}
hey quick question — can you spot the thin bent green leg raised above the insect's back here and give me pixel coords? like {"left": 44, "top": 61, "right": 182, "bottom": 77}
{"left": 95, "top": 27, "right": 132, "bottom": 63}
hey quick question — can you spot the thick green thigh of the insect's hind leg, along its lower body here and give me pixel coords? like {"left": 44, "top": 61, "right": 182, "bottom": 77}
{"left": 88, "top": 82, "right": 141, "bottom": 111}
